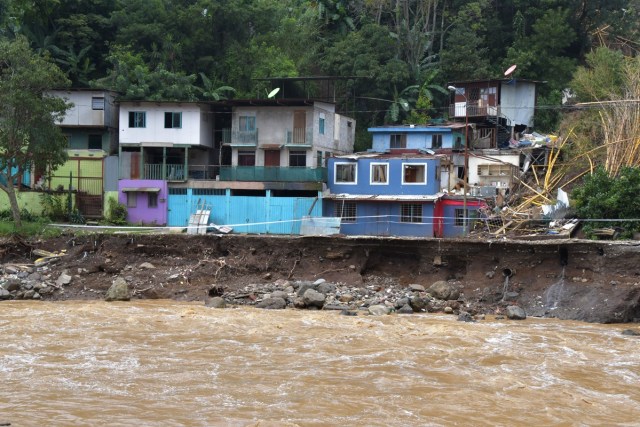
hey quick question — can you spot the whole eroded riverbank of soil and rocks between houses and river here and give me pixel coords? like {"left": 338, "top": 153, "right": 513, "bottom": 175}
{"left": 0, "top": 235, "right": 640, "bottom": 323}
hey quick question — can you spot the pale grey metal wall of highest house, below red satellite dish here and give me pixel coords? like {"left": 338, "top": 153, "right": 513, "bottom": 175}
{"left": 500, "top": 79, "right": 536, "bottom": 127}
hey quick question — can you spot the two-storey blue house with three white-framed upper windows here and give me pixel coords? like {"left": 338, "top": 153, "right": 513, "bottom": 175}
{"left": 323, "top": 153, "right": 443, "bottom": 237}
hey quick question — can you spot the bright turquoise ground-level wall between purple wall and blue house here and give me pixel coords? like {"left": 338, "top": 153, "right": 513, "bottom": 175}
{"left": 168, "top": 188, "right": 322, "bottom": 235}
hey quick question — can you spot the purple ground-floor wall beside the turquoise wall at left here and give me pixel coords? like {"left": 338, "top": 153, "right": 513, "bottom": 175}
{"left": 118, "top": 179, "right": 167, "bottom": 225}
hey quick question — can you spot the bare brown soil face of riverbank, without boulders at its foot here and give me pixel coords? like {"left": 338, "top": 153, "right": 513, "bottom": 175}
{"left": 0, "top": 235, "right": 640, "bottom": 322}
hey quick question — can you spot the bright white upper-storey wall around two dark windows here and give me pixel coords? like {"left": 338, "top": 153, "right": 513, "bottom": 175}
{"left": 119, "top": 102, "right": 213, "bottom": 147}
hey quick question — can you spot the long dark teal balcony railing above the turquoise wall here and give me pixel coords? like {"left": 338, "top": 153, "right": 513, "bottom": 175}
{"left": 220, "top": 166, "right": 327, "bottom": 182}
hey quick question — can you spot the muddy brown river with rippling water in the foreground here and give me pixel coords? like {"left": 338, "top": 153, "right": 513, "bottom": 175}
{"left": 0, "top": 301, "right": 640, "bottom": 426}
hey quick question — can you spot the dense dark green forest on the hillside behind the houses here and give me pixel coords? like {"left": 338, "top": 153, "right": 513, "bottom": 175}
{"left": 0, "top": 0, "right": 640, "bottom": 148}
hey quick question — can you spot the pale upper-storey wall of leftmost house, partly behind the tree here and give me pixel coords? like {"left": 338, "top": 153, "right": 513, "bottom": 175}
{"left": 47, "top": 90, "right": 118, "bottom": 128}
